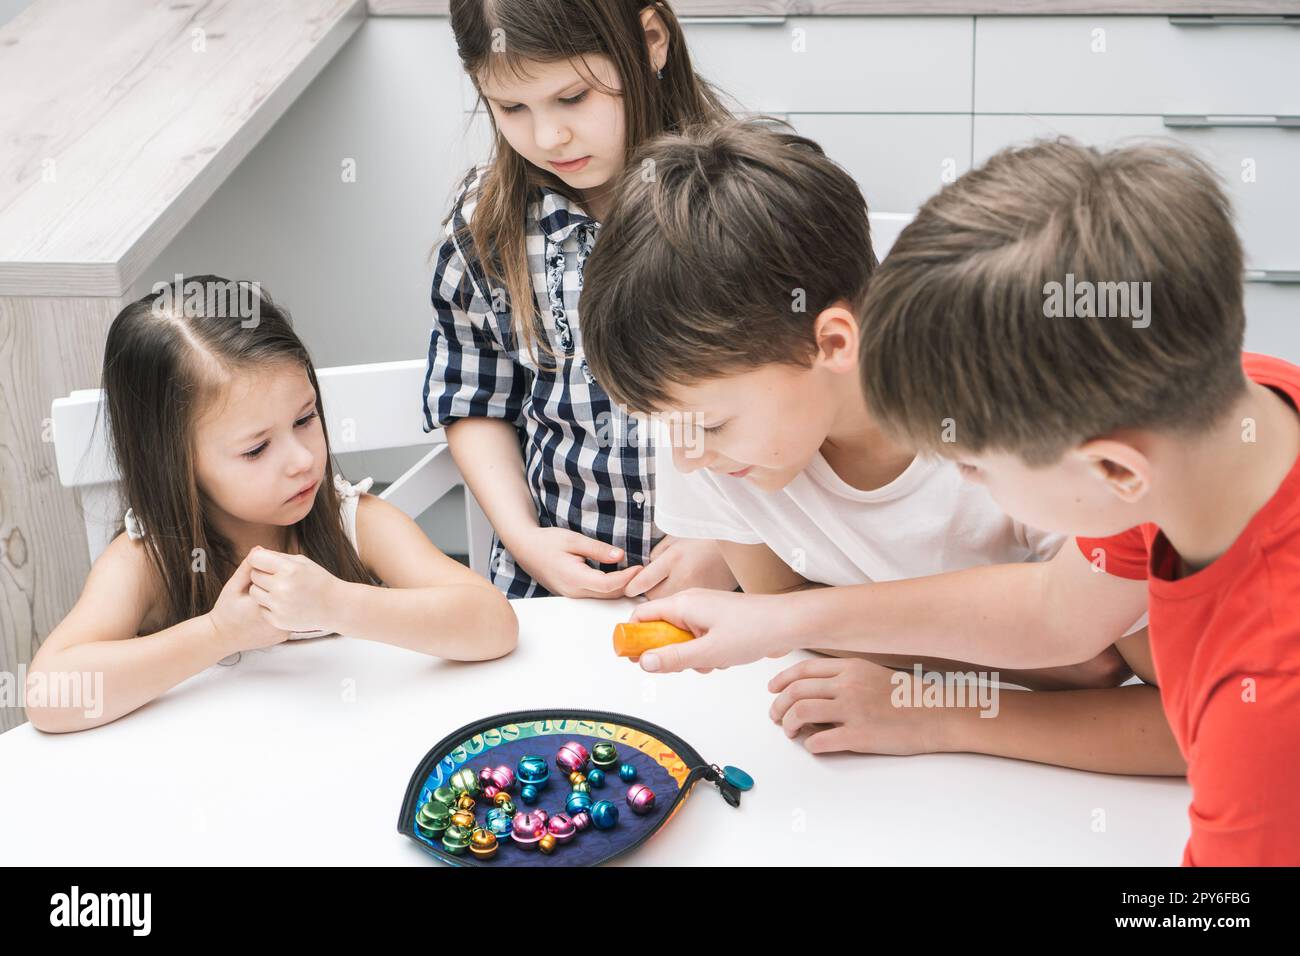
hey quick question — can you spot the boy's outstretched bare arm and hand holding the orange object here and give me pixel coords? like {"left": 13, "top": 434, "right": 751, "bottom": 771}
{"left": 633, "top": 544, "right": 1147, "bottom": 671}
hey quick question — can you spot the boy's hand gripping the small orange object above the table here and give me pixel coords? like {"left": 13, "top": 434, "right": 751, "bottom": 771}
{"left": 621, "top": 588, "right": 792, "bottom": 674}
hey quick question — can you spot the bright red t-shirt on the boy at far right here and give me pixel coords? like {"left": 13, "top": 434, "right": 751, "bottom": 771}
{"left": 1078, "top": 354, "right": 1300, "bottom": 866}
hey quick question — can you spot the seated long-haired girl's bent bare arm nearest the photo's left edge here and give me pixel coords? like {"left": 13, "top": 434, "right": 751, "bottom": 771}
{"left": 25, "top": 533, "right": 234, "bottom": 734}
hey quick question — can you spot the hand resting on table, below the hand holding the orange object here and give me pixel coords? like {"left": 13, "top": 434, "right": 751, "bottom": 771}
{"left": 767, "top": 657, "right": 945, "bottom": 756}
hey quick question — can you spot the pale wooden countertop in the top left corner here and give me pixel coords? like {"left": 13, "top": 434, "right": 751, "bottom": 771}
{"left": 0, "top": 0, "right": 365, "bottom": 297}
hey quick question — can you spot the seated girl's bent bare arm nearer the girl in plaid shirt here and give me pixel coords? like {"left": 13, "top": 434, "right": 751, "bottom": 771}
{"left": 330, "top": 494, "right": 519, "bottom": 661}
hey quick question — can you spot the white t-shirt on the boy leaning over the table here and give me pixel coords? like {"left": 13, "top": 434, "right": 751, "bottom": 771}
{"left": 654, "top": 436, "right": 1065, "bottom": 587}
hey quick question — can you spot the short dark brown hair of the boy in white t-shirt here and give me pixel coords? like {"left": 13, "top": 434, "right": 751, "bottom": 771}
{"left": 579, "top": 117, "right": 876, "bottom": 412}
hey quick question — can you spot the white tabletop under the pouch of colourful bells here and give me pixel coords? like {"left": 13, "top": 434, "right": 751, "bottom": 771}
{"left": 0, "top": 598, "right": 1190, "bottom": 866}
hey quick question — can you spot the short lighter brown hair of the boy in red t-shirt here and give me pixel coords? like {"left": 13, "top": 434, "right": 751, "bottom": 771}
{"left": 861, "top": 139, "right": 1245, "bottom": 464}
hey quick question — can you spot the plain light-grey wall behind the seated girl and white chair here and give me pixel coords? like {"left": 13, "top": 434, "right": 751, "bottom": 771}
{"left": 133, "top": 17, "right": 484, "bottom": 553}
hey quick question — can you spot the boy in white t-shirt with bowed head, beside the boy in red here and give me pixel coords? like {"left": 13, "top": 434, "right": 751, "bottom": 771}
{"left": 582, "top": 121, "right": 1186, "bottom": 774}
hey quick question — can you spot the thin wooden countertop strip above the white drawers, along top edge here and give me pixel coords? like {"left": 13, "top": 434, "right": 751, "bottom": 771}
{"left": 369, "top": 0, "right": 1300, "bottom": 17}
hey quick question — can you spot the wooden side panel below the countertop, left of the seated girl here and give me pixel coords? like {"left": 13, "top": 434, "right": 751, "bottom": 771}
{"left": 0, "top": 297, "right": 122, "bottom": 732}
